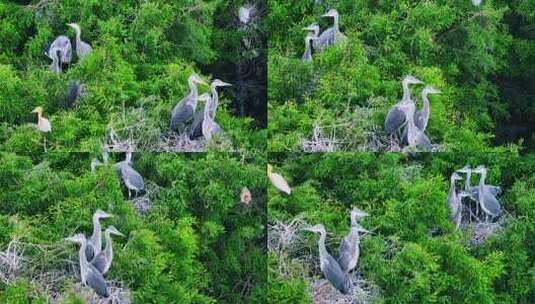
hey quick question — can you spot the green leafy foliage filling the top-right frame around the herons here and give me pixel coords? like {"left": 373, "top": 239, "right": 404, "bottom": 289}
{"left": 268, "top": 0, "right": 533, "bottom": 151}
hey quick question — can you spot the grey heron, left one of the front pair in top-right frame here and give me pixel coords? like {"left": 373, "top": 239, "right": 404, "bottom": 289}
{"left": 385, "top": 75, "right": 422, "bottom": 135}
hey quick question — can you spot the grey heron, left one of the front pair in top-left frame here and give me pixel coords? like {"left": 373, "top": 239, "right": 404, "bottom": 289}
{"left": 170, "top": 74, "right": 206, "bottom": 132}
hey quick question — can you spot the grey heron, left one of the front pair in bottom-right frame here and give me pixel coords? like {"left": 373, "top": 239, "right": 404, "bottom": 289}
{"left": 304, "top": 224, "right": 351, "bottom": 294}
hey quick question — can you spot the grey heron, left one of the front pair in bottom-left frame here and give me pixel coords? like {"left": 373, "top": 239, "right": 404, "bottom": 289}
{"left": 66, "top": 233, "right": 110, "bottom": 298}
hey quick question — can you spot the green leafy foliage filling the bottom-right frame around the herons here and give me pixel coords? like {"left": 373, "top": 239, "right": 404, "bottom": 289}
{"left": 268, "top": 153, "right": 535, "bottom": 303}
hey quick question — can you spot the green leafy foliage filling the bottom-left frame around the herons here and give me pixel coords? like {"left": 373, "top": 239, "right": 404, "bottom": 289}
{"left": 0, "top": 152, "right": 267, "bottom": 303}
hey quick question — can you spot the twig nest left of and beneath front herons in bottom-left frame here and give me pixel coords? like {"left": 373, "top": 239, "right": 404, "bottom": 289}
{"left": 0, "top": 239, "right": 130, "bottom": 304}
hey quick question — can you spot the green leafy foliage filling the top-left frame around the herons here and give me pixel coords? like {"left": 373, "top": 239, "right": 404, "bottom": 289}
{"left": 0, "top": 0, "right": 265, "bottom": 152}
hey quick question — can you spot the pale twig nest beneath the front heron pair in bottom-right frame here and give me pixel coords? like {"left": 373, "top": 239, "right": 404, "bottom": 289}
{"left": 309, "top": 273, "right": 380, "bottom": 304}
